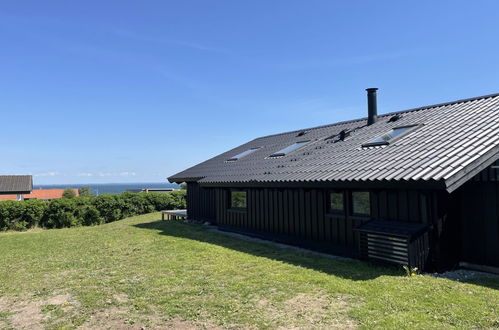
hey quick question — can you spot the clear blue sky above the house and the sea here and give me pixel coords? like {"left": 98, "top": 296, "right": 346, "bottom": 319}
{"left": 0, "top": 0, "right": 499, "bottom": 184}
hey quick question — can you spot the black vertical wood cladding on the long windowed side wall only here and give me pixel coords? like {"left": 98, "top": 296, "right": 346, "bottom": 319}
{"left": 188, "top": 184, "right": 438, "bottom": 255}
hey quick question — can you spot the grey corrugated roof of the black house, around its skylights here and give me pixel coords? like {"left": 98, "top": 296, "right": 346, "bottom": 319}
{"left": 168, "top": 94, "right": 499, "bottom": 191}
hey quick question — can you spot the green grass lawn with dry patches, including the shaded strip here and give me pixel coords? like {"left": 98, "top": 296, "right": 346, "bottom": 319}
{"left": 0, "top": 213, "right": 499, "bottom": 329}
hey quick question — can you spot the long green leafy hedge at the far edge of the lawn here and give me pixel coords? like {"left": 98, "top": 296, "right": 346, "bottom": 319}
{"left": 0, "top": 190, "right": 186, "bottom": 230}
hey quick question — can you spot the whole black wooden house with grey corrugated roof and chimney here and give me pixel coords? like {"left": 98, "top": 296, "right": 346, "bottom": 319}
{"left": 168, "top": 89, "right": 499, "bottom": 270}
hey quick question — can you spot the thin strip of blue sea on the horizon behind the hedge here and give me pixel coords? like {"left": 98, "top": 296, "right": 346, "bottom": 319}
{"left": 33, "top": 182, "right": 180, "bottom": 195}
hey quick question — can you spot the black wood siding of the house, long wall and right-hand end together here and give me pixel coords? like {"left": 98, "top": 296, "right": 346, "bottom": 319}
{"left": 187, "top": 162, "right": 499, "bottom": 270}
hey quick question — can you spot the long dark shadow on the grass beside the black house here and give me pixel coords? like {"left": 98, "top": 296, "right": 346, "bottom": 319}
{"left": 134, "top": 220, "right": 402, "bottom": 281}
